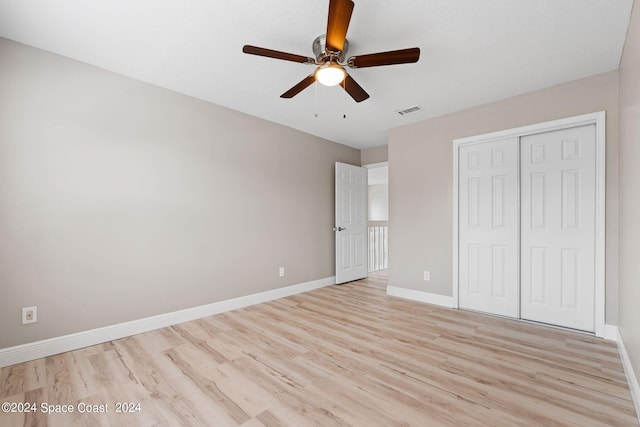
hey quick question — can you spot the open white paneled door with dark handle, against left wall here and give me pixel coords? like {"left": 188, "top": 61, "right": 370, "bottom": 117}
{"left": 334, "top": 162, "right": 368, "bottom": 283}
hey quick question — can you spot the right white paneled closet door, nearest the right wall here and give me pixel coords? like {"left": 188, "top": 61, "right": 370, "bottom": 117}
{"left": 520, "top": 125, "right": 596, "bottom": 331}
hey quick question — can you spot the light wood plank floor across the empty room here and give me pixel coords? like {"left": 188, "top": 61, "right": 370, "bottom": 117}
{"left": 0, "top": 276, "right": 638, "bottom": 427}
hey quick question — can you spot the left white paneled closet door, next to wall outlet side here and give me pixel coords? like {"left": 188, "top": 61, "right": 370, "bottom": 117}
{"left": 458, "top": 138, "right": 519, "bottom": 317}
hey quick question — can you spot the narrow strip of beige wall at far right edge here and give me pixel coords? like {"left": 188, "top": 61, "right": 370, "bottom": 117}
{"left": 620, "top": 2, "right": 640, "bottom": 398}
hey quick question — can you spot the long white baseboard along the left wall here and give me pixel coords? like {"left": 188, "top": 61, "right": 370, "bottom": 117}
{"left": 0, "top": 276, "right": 336, "bottom": 368}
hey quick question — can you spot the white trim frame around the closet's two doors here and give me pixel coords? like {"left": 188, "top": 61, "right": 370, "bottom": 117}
{"left": 452, "top": 111, "right": 606, "bottom": 338}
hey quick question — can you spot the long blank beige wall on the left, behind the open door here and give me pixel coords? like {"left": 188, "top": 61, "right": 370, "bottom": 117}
{"left": 0, "top": 39, "right": 360, "bottom": 348}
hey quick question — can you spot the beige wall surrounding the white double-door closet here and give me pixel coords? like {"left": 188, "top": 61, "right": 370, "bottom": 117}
{"left": 389, "top": 71, "right": 618, "bottom": 324}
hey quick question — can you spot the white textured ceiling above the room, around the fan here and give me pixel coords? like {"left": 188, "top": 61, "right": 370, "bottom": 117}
{"left": 0, "top": 0, "right": 633, "bottom": 148}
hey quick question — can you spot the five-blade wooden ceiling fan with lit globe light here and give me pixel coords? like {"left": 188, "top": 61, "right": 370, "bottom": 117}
{"left": 242, "top": 0, "right": 420, "bottom": 102}
